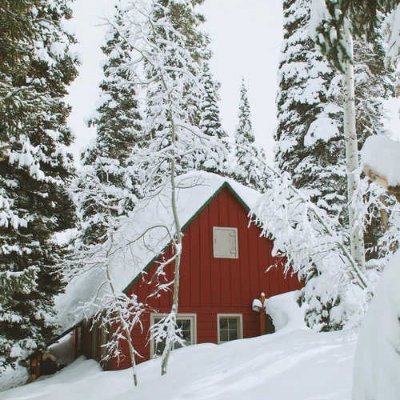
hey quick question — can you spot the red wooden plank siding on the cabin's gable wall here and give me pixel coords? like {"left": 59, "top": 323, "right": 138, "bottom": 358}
{"left": 104, "top": 188, "right": 302, "bottom": 369}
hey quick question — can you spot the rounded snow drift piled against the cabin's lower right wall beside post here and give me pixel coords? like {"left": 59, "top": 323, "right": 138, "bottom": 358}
{"left": 266, "top": 290, "right": 307, "bottom": 331}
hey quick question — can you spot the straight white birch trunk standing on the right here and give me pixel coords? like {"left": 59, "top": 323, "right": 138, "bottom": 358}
{"left": 344, "top": 20, "right": 365, "bottom": 269}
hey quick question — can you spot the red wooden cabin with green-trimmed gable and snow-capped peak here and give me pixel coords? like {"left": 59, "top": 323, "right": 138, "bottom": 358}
{"left": 61, "top": 173, "right": 303, "bottom": 369}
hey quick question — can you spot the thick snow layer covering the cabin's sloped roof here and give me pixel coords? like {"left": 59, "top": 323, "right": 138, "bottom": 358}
{"left": 56, "top": 172, "right": 261, "bottom": 330}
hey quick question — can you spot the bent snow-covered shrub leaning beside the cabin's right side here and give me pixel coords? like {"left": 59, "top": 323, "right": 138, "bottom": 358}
{"left": 253, "top": 174, "right": 368, "bottom": 330}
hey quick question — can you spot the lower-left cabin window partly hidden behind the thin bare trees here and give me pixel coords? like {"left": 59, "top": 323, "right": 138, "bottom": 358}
{"left": 150, "top": 314, "right": 197, "bottom": 357}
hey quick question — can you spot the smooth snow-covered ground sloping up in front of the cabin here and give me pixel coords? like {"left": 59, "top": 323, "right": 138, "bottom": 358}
{"left": 0, "top": 292, "right": 356, "bottom": 400}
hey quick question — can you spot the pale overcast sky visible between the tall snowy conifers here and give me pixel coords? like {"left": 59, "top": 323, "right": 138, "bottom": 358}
{"left": 69, "top": 0, "right": 282, "bottom": 162}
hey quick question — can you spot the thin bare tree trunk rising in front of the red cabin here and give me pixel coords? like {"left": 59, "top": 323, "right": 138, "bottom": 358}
{"left": 161, "top": 112, "right": 182, "bottom": 375}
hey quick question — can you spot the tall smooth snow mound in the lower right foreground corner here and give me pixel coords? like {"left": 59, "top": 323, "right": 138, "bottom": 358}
{"left": 353, "top": 252, "right": 400, "bottom": 400}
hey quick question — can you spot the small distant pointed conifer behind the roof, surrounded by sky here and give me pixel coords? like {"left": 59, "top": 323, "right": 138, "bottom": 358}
{"left": 233, "top": 79, "right": 269, "bottom": 192}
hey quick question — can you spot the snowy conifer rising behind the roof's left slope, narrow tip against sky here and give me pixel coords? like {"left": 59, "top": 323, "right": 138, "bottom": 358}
{"left": 74, "top": 7, "right": 144, "bottom": 248}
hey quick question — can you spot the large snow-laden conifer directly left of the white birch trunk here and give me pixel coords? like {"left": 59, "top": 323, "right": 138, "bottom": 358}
{"left": 275, "top": 0, "right": 346, "bottom": 219}
